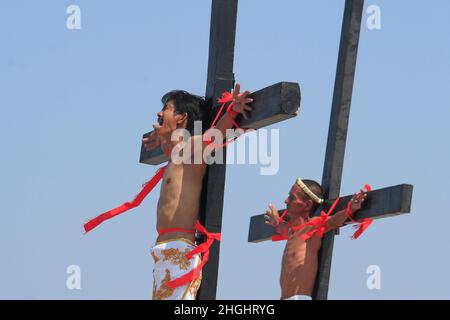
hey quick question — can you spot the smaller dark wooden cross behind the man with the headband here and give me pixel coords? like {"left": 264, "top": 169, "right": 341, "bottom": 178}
{"left": 248, "top": 0, "right": 413, "bottom": 300}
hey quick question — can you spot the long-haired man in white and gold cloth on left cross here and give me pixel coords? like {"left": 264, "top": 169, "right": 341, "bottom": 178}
{"left": 143, "top": 84, "right": 253, "bottom": 300}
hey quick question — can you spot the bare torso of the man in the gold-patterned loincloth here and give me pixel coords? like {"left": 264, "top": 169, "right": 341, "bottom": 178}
{"left": 156, "top": 162, "right": 206, "bottom": 241}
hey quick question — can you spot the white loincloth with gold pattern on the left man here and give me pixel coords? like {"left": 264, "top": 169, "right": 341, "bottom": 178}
{"left": 151, "top": 239, "right": 201, "bottom": 300}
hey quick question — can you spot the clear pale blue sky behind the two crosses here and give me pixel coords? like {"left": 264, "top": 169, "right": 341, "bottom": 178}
{"left": 0, "top": 0, "right": 450, "bottom": 299}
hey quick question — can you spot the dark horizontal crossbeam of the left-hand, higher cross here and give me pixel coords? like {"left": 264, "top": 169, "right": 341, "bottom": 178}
{"left": 139, "top": 82, "right": 300, "bottom": 165}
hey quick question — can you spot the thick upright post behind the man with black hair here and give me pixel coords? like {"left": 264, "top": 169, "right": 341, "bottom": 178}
{"left": 198, "top": 0, "right": 238, "bottom": 300}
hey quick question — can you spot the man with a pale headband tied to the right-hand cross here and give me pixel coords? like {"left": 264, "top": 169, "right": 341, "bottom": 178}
{"left": 264, "top": 179, "right": 367, "bottom": 300}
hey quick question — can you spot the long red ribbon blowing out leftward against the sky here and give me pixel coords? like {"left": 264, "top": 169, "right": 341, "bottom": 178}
{"left": 84, "top": 165, "right": 167, "bottom": 233}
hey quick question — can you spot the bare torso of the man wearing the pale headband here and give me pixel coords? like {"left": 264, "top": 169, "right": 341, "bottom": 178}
{"left": 280, "top": 224, "right": 321, "bottom": 299}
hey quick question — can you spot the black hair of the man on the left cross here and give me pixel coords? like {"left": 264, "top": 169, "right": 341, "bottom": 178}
{"left": 161, "top": 90, "right": 206, "bottom": 135}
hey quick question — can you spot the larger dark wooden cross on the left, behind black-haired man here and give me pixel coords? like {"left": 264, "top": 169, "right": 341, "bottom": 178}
{"left": 140, "top": 0, "right": 300, "bottom": 300}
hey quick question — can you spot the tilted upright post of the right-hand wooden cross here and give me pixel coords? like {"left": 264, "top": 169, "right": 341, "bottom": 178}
{"left": 313, "top": 0, "right": 364, "bottom": 300}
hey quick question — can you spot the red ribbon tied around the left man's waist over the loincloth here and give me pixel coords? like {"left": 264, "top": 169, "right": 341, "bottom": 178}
{"left": 165, "top": 221, "right": 220, "bottom": 288}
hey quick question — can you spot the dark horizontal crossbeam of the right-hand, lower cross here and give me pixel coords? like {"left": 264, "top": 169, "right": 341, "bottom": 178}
{"left": 248, "top": 184, "right": 413, "bottom": 243}
